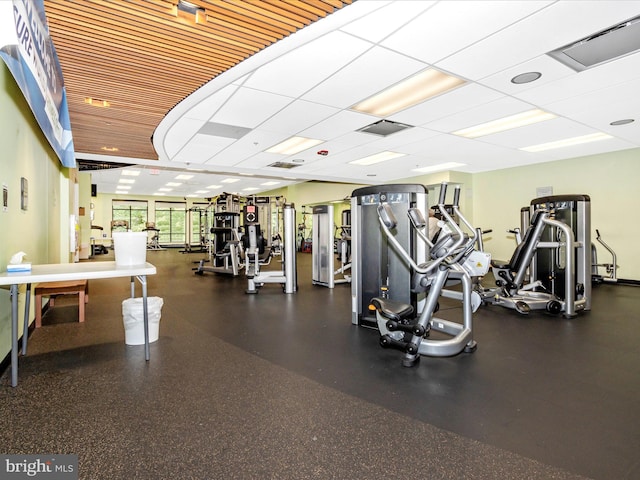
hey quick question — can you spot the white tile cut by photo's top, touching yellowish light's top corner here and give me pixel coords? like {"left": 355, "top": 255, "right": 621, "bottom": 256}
{"left": 381, "top": 1, "right": 553, "bottom": 64}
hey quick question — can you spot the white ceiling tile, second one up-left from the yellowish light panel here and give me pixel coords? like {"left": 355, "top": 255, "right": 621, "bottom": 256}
{"left": 244, "top": 31, "right": 371, "bottom": 97}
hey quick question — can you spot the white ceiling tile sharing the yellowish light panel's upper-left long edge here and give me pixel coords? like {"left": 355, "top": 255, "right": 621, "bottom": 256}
{"left": 302, "top": 47, "right": 427, "bottom": 108}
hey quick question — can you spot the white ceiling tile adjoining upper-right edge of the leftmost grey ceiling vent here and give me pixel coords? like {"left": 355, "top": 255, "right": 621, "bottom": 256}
{"left": 211, "top": 87, "right": 293, "bottom": 128}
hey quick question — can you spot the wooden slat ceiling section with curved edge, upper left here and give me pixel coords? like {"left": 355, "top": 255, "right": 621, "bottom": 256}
{"left": 45, "top": 0, "right": 352, "bottom": 159}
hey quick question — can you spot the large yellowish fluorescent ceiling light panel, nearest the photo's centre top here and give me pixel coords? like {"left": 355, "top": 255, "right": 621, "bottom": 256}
{"left": 351, "top": 68, "right": 465, "bottom": 117}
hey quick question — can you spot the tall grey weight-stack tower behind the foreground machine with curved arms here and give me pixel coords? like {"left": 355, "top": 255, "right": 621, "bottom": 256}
{"left": 351, "top": 184, "right": 427, "bottom": 328}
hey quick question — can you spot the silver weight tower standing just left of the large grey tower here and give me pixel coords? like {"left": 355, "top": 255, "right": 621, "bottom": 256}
{"left": 311, "top": 205, "right": 351, "bottom": 288}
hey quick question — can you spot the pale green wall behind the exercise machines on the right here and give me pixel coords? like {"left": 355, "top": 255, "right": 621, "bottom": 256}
{"left": 472, "top": 149, "right": 640, "bottom": 280}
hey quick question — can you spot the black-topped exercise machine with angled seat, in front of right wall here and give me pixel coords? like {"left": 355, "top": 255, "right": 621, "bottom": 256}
{"left": 482, "top": 195, "right": 591, "bottom": 318}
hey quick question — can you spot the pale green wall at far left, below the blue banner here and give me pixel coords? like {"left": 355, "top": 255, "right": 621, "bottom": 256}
{"left": 0, "top": 62, "right": 69, "bottom": 359}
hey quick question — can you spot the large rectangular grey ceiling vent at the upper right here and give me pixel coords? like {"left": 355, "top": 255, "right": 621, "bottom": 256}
{"left": 548, "top": 16, "right": 640, "bottom": 72}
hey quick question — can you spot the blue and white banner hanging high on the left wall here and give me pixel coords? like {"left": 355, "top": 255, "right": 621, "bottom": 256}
{"left": 0, "top": 0, "right": 76, "bottom": 168}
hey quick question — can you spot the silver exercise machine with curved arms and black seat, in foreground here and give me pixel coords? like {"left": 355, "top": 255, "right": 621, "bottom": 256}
{"left": 371, "top": 183, "right": 490, "bottom": 367}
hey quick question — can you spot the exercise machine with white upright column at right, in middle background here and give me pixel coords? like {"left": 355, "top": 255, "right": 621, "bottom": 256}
{"left": 241, "top": 203, "right": 298, "bottom": 294}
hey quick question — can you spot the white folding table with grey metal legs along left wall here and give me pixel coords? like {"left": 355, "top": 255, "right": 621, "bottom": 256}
{"left": 0, "top": 262, "right": 156, "bottom": 387}
